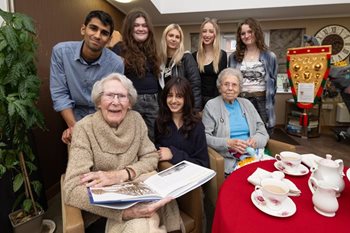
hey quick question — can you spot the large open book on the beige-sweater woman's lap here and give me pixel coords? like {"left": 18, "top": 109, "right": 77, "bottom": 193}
{"left": 88, "top": 161, "right": 216, "bottom": 209}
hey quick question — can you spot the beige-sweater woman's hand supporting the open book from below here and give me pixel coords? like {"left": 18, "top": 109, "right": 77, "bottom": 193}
{"left": 123, "top": 197, "right": 173, "bottom": 221}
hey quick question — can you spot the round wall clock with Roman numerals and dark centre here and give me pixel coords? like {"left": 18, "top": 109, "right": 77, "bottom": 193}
{"left": 315, "top": 24, "right": 350, "bottom": 64}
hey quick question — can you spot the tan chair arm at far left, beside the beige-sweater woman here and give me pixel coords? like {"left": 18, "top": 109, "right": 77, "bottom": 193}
{"left": 61, "top": 174, "right": 85, "bottom": 233}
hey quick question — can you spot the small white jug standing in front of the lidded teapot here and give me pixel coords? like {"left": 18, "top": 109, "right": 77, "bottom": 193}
{"left": 308, "top": 177, "right": 339, "bottom": 217}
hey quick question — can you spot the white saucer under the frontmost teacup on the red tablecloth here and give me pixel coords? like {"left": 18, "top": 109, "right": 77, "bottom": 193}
{"left": 250, "top": 190, "right": 297, "bottom": 218}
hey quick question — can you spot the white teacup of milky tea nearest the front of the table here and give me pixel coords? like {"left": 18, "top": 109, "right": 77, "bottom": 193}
{"left": 255, "top": 178, "right": 289, "bottom": 209}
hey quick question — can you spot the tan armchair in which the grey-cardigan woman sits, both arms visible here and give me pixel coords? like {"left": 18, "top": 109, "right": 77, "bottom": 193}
{"left": 204, "top": 139, "right": 296, "bottom": 206}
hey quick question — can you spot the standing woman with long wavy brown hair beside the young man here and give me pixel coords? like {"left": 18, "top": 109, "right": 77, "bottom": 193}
{"left": 112, "top": 9, "right": 160, "bottom": 140}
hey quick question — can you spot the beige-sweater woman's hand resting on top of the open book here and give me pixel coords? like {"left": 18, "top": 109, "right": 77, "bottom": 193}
{"left": 80, "top": 169, "right": 129, "bottom": 187}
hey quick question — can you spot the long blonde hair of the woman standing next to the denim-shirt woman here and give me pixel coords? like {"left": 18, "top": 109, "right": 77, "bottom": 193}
{"left": 197, "top": 18, "right": 221, "bottom": 73}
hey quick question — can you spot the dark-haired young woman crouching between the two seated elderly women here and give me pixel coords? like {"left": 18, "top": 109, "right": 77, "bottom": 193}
{"left": 155, "top": 77, "right": 209, "bottom": 167}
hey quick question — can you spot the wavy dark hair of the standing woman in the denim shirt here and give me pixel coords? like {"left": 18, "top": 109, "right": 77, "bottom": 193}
{"left": 234, "top": 18, "right": 268, "bottom": 62}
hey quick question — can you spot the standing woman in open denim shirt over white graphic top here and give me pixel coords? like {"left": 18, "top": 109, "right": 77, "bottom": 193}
{"left": 229, "top": 18, "right": 278, "bottom": 134}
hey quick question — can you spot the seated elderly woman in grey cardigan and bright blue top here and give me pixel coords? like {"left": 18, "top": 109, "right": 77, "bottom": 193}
{"left": 202, "top": 68, "right": 269, "bottom": 175}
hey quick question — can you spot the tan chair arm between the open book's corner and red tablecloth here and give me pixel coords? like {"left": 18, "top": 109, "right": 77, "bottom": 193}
{"left": 204, "top": 147, "right": 225, "bottom": 206}
